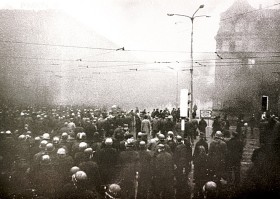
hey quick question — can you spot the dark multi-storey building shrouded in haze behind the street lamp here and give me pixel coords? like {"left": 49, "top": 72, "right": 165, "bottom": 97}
{"left": 213, "top": 0, "right": 280, "bottom": 116}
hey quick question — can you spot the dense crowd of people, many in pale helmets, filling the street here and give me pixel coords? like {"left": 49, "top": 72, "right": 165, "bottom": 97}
{"left": 0, "top": 106, "right": 280, "bottom": 199}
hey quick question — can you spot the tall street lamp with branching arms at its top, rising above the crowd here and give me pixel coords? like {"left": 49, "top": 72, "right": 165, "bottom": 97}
{"left": 167, "top": 5, "right": 210, "bottom": 118}
